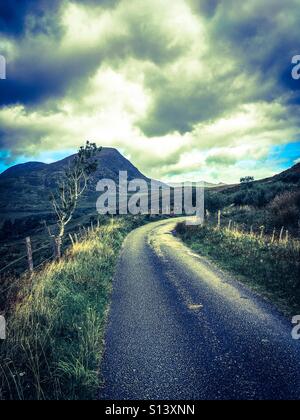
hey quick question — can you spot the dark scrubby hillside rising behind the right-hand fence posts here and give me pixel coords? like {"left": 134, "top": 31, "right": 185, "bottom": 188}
{"left": 205, "top": 164, "right": 300, "bottom": 237}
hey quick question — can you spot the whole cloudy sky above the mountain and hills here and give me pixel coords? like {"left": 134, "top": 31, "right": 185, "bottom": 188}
{"left": 0, "top": 0, "right": 300, "bottom": 183}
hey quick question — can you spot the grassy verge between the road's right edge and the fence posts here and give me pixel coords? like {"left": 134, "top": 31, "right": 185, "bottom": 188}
{"left": 177, "top": 224, "right": 300, "bottom": 315}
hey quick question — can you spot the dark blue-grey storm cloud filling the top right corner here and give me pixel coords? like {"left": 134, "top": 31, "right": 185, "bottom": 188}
{"left": 210, "top": 0, "right": 300, "bottom": 94}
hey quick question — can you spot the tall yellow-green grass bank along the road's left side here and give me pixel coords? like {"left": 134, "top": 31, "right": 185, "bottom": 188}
{"left": 0, "top": 219, "right": 143, "bottom": 400}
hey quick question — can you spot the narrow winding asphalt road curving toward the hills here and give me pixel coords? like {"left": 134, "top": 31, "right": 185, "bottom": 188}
{"left": 100, "top": 220, "right": 300, "bottom": 400}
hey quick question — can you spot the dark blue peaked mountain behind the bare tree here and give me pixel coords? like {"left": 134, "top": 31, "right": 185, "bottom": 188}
{"left": 0, "top": 148, "right": 150, "bottom": 217}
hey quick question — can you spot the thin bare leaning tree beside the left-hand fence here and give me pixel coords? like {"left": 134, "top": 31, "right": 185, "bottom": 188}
{"left": 48, "top": 141, "right": 102, "bottom": 259}
